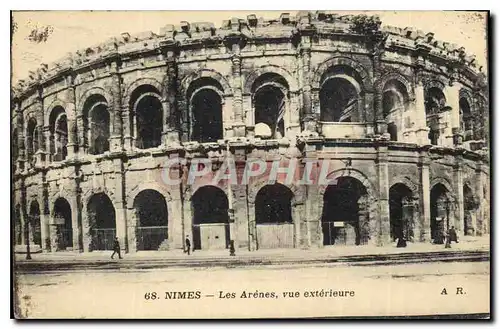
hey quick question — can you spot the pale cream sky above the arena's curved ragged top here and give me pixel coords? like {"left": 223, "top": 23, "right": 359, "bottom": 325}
{"left": 12, "top": 10, "right": 487, "bottom": 82}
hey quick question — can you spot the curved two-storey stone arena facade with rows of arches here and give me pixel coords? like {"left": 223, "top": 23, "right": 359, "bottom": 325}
{"left": 12, "top": 12, "right": 490, "bottom": 252}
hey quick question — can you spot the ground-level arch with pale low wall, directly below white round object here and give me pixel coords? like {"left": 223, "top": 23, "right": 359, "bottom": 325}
{"left": 255, "top": 183, "right": 294, "bottom": 249}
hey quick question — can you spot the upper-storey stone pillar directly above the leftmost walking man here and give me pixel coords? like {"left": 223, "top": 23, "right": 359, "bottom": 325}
{"left": 109, "top": 61, "right": 123, "bottom": 152}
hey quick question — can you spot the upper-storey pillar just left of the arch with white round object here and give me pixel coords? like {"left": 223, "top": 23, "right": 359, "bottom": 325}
{"left": 231, "top": 40, "right": 245, "bottom": 137}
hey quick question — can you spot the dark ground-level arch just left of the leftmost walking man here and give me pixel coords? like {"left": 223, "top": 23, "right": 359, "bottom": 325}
{"left": 87, "top": 193, "right": 116, "bottom": 251}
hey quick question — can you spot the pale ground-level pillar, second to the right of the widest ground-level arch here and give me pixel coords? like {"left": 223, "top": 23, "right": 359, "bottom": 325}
{"left": 417, "top": 150, "right": 431, "bottom": 242}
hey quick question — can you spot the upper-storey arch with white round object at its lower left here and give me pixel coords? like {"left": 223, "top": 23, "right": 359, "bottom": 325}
{"left": 252, "top": 73, "right": 289, "bottom": 139}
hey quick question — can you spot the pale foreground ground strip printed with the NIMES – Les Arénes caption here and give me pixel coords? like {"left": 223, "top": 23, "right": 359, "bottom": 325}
{"left": 13, "top": 262, "right": 490, "bottom": 318}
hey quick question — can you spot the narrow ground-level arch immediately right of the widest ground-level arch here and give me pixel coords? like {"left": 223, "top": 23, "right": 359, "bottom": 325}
{"left": 389, "top": 183, "right": 415, "bottom": 241}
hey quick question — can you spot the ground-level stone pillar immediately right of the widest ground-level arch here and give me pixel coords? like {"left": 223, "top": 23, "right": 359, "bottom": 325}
{"left": 375, "top": 145, "right": 391, "bottom": 246}
